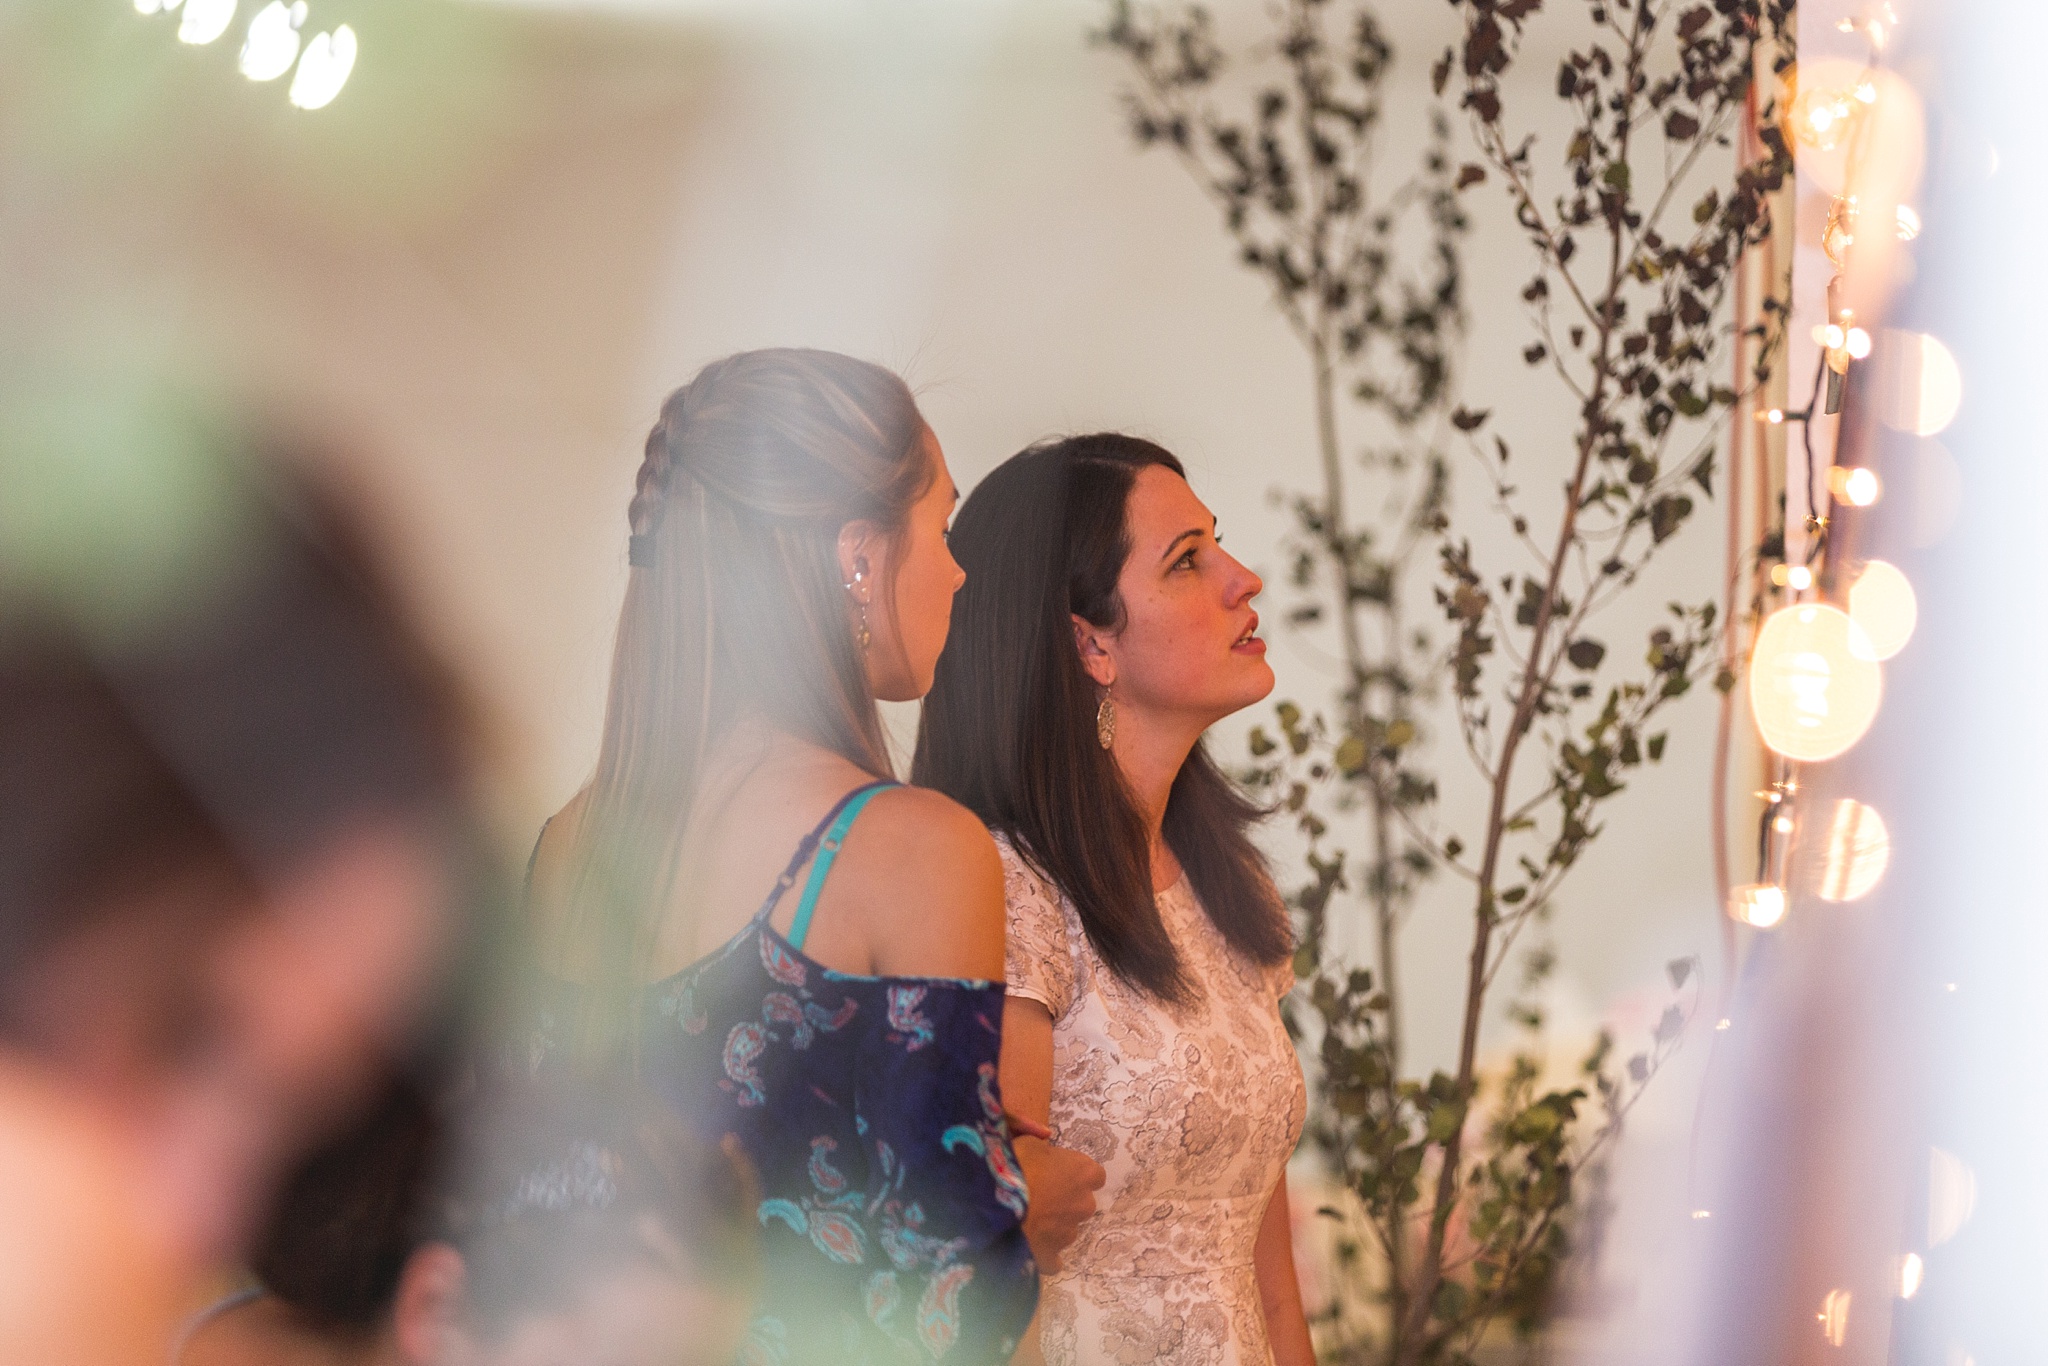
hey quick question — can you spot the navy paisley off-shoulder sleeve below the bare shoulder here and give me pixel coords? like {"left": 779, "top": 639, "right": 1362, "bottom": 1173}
{"left": 847, "top": 979, "right": 1038, "bottom": 1362}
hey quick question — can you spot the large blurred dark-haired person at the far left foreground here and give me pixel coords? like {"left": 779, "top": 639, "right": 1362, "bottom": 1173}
{"left": 0, "top": 385, "right": 469, "bottom": 1366}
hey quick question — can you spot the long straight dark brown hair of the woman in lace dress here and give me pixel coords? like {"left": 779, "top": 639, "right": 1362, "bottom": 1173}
{"left": 911, "top": 432, "right": 1292, "bottom": 1001}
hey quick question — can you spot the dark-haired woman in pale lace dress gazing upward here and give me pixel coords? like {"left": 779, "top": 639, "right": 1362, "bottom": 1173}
{"left": 915, "top": 434, "right": 1313, "bottom": 1366}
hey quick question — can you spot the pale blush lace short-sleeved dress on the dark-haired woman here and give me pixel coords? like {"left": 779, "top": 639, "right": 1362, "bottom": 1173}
{"left": 997, "top": 838, "right": 1309, "bottom": 1366}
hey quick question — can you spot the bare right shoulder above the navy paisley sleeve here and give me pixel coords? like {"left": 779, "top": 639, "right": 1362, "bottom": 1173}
{"left": 840, "top": 786, "right": 1004, "bottom": 981}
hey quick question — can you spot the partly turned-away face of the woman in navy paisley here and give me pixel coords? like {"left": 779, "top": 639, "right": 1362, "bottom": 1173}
{"left": 868, "top": 428, "right": 967, "bottom": 702}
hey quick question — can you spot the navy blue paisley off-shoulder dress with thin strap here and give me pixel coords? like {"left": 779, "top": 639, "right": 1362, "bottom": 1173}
{"left": 532, "top": 782, "right": 1038, "bottom": 1366}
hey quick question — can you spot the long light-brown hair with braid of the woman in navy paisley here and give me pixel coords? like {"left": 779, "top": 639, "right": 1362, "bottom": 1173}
{"left": 563, "top": 350, "right": 936, "bottom": 1051}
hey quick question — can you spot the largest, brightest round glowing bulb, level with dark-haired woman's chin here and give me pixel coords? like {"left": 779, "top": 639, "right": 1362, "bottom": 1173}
{"left": 1749, "top": 602, "right": 1884, "bottom": 764}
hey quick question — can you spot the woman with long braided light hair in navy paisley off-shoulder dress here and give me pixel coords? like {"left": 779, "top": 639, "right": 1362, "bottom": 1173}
{"left": 520, "top": 350, "right": 1081, "bottom": 1364}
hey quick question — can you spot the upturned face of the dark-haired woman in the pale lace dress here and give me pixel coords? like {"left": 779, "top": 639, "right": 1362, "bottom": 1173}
{"left": 1106, "top": 465, "right": 1274, "bottom": 729}
